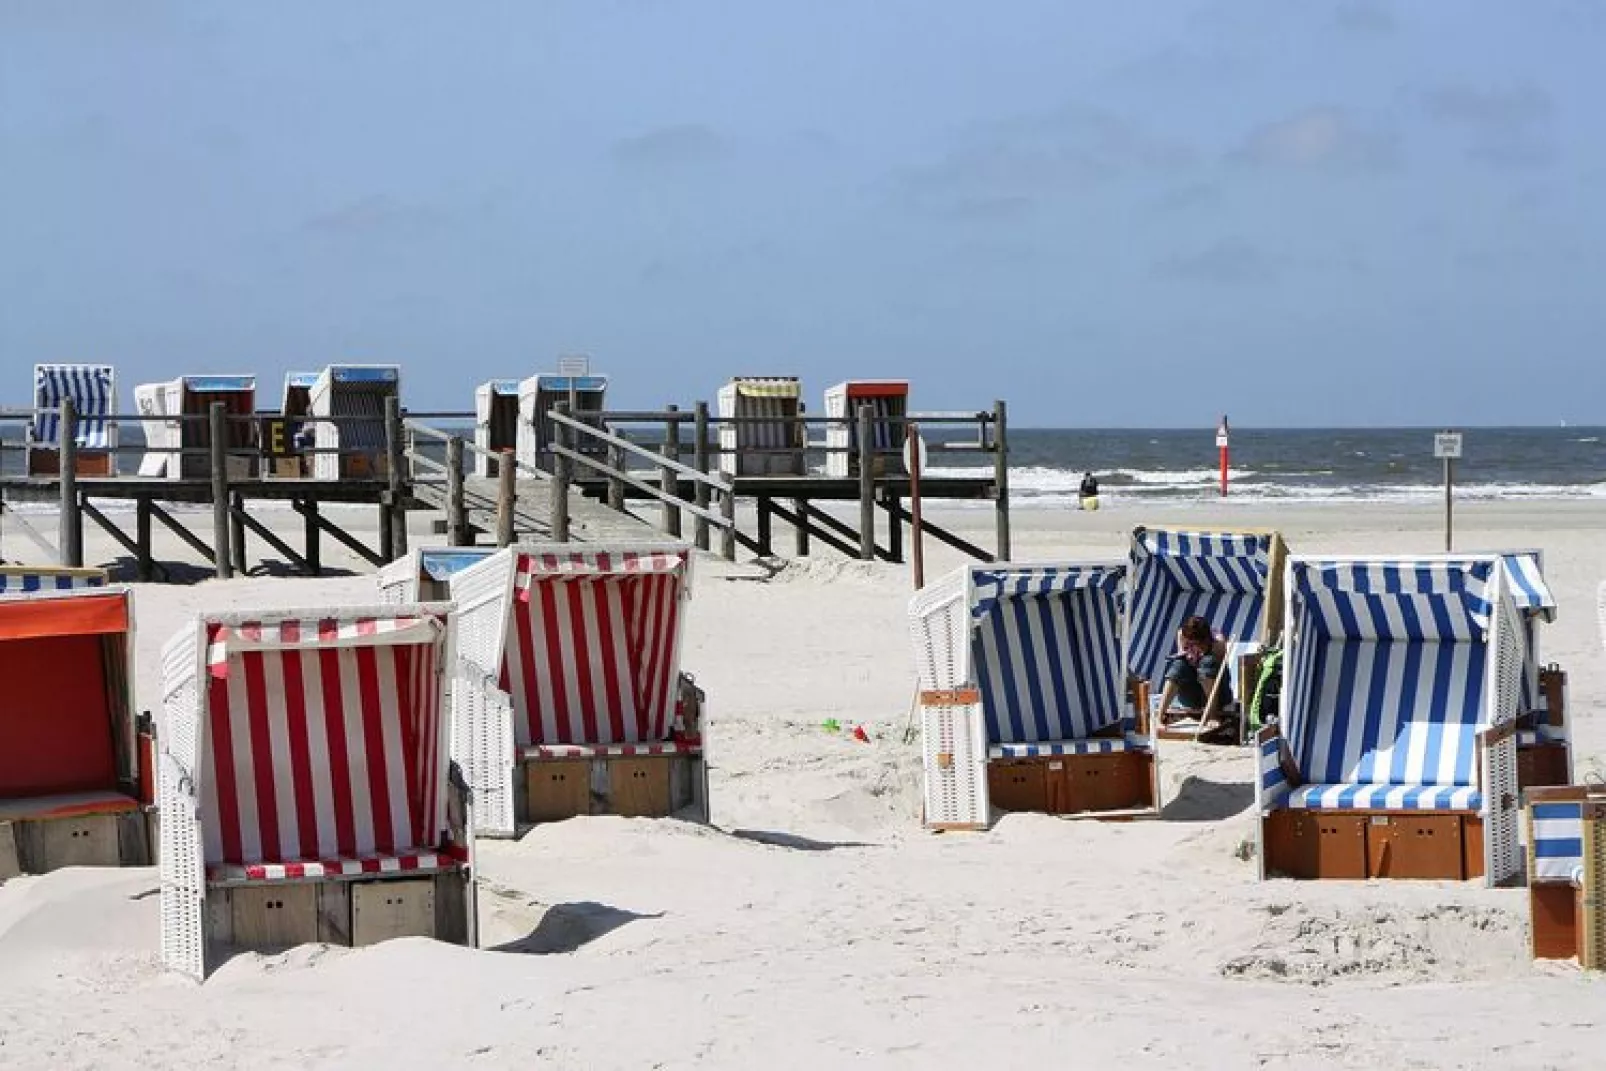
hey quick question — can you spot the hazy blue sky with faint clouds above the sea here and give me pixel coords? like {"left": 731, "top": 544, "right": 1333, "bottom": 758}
{"left": 0, "top": 0, "right": 1606, "bottom": 427}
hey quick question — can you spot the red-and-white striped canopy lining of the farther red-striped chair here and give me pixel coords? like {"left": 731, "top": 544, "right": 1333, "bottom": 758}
{"left": 501, "top": 549, "right": 691, "bottom": 748}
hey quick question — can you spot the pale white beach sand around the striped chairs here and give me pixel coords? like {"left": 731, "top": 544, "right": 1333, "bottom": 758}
{"left": 0, "top": 504, "right": 1606, "bottom": 1068}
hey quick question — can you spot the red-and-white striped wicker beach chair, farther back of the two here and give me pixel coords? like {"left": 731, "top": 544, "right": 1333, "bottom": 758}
{"left": 451, "top": 544, "right": 708, "bottom": 837}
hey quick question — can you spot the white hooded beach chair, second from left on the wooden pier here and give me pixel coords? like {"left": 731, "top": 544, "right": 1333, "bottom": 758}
{"left": 133, "top": 376, "right": 257, "bottom": 480}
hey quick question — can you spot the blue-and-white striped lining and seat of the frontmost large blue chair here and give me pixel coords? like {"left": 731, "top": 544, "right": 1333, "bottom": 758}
{"left": 1283, "top": 559, "right": 1495, "bottom": 808}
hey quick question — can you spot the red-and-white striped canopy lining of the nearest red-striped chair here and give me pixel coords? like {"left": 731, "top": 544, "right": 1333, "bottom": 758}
{"left": 199, "top": 615, "right": 446, "bottom": 865}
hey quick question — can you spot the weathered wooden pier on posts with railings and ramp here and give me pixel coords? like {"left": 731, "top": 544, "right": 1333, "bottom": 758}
{"left": 0, "top": 398, "right": 1010, "bottom": 580}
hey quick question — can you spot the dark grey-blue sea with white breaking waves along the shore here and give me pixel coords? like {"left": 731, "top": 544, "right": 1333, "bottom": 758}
{"left": 931, "top": 427, "right": 1606, "bottom": 507}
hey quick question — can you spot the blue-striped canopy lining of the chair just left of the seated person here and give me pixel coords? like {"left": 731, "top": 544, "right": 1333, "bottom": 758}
{"left": 970, "top": 564, "right": 1126, "bottom": 745}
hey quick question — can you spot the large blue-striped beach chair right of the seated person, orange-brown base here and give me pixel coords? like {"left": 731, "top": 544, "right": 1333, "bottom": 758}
{"left": 1256, "top": 556, "right": 1524, "bottom": 885}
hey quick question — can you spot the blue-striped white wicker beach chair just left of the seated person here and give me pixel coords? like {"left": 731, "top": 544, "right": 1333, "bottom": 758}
{"left": 909, "top": 560, "right": 1160, "bottom": 825}
